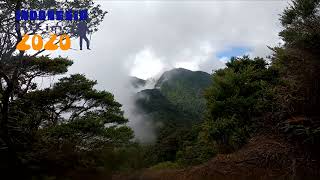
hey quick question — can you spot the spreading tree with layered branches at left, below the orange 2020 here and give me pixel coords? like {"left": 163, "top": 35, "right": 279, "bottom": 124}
{"left": 1, "top": 57, "right": 133, "bottom": 178}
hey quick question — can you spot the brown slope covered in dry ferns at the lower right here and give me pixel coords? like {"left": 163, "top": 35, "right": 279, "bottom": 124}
{"left": 113, "top": 134, "right": 319, "bottom": 180}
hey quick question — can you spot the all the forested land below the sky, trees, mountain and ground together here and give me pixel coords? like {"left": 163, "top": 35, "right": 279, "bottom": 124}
{"left": 0, "top": 0, "right": 320, "bottom": 180}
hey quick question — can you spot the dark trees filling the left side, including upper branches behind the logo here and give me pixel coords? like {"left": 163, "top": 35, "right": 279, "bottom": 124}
{"left": 0, "top": 0, "right": 138, "bottom": 179}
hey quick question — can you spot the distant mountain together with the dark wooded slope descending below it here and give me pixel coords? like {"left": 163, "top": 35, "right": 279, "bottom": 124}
{"left": 131, "top": 68, "right": 210, "bottom": 164}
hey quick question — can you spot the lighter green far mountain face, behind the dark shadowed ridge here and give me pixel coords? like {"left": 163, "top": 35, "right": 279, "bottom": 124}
{"left": 155, "top": 68, "right": 211, "bottom": 119}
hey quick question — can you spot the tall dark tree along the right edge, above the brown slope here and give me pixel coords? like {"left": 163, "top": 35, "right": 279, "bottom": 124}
{"left": 272, "top": 0, "right": 320, "bottom": 157}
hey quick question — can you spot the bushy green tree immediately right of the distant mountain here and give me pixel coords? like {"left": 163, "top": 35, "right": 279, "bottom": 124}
{"left": 202, "top": 56, "right": 279, "bottom": 151}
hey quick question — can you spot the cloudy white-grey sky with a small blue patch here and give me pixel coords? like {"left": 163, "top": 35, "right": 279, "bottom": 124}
{"left": 48, "top": 0, "right": 288, "bottom": 141}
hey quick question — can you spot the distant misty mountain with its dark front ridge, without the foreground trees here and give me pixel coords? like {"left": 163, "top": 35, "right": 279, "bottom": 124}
{"left": 131, "top": 68, "right": 211, "bottom": 131}
